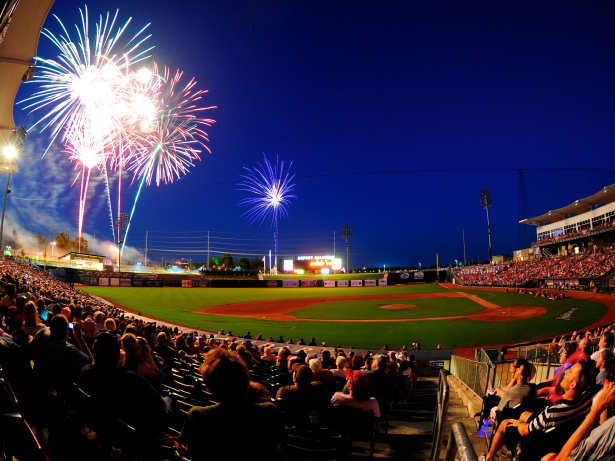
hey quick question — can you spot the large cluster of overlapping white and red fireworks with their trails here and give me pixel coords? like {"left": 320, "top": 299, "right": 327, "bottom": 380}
{"left": 21, "top": 7, "right": 214, "bottom": 255}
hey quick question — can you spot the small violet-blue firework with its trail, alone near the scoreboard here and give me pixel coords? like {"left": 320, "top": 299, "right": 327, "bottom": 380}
{"left": 237, "top": 154, "right": 297, "bottom": 268}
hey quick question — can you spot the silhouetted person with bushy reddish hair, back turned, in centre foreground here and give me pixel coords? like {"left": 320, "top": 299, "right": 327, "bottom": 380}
{"left": 179, "top": 348, "right": 281, "bottom": 461}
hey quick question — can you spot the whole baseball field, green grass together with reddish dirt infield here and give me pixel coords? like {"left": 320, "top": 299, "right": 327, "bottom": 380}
{"left": 81, "top": 284, "right": 615, "bottom": 349}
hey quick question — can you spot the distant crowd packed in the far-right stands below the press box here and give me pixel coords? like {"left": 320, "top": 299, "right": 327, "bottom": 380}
{"left": 454, "top": 248, "right": 615, "bottom": 286}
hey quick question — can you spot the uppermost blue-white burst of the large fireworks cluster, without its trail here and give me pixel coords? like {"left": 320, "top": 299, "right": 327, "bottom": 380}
{"left": 21, "top": 7, "right": 153, "bottom": 155}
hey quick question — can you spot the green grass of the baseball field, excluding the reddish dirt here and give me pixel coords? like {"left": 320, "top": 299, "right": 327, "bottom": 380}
{"left": 82, "top": 285, "right": 607, "bottom": 349}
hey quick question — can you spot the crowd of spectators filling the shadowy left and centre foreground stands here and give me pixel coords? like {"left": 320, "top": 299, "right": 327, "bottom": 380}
{"left": 0, "top": 259, "right": 428, "bottom": 460}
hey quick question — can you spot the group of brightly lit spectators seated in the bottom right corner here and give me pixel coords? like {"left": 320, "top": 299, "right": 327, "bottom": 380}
{"left": 480, "top": 325, "right": 615, "bottom": 461}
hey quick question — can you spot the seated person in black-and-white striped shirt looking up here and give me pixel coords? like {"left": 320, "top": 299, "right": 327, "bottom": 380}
{"left": 479, "top": 361, "right": 593, "bottom": 461}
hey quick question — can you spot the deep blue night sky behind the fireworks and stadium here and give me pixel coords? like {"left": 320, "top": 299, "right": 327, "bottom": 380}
{"left": 9, "top": 0, "right": 615, "bottom": 267}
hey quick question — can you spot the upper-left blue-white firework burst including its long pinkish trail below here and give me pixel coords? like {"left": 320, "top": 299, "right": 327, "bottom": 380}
{"left": 21, "top": 7, "right": 153, "bottom": 242}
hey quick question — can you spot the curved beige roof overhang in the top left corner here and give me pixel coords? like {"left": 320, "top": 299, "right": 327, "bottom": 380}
{"left": 0, "top": 0, "right": 53, "bottom": 172}
